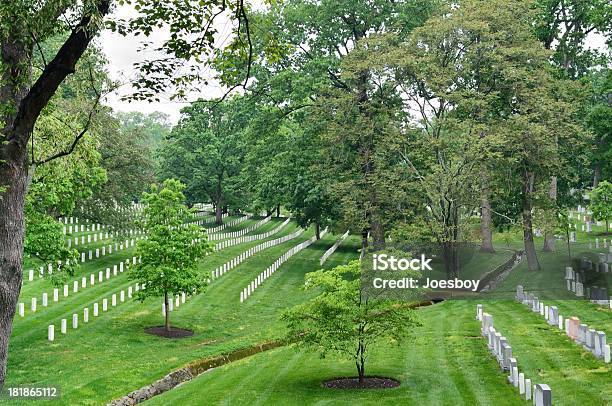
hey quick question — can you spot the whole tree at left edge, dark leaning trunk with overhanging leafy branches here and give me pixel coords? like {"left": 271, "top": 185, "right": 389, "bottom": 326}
{"left": 0, "top": 0, "right": 248, "bottom": 388}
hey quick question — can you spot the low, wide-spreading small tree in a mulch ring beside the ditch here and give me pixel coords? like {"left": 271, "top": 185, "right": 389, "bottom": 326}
{"left": 281, "top": 261, "right": 419, "bottom": 385}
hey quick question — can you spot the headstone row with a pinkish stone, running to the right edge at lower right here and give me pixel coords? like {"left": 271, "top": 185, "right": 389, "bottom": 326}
{"left": 516, "top": 285, "right": 610, "bottom": 363}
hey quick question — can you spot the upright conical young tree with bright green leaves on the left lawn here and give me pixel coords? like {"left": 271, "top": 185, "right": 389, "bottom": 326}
{"left": 130, "top": 179, "right": 210, "bottom": 331}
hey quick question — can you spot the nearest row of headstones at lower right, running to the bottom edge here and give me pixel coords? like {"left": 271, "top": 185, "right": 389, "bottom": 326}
{"left": 476, "top": 304, "right": 552, "bottom": 406}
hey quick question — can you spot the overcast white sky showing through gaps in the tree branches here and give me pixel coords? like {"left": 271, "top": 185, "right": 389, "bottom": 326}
{"left": 101, "top": 0, "right": 605, "bottom": 124}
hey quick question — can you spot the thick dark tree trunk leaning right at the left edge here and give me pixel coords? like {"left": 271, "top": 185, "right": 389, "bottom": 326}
{"left": 0, "top": 0, "right": 110, "bottom": 391}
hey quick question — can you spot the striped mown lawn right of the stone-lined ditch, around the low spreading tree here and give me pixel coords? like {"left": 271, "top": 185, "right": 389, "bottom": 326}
{"left": 146, "top": 300, "right": 612, "bottom": 405}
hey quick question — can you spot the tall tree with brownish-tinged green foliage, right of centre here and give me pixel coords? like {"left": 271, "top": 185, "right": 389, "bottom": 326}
{"left": 394, "top": 0, "right": 575, "bottom": 269}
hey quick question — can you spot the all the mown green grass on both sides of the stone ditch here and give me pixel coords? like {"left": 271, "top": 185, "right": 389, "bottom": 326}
{"left": 0, "top": 214, "right": 612, "bottom": 405}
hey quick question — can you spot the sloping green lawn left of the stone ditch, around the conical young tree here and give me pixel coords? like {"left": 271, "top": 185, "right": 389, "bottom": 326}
{"left": 6, "top": 219, "right": 357, "bottom": 404}
